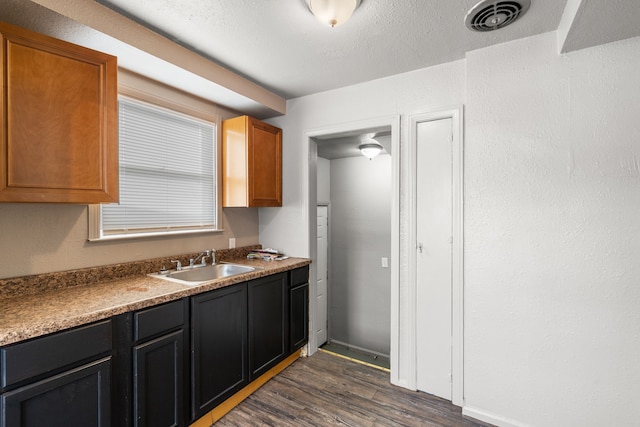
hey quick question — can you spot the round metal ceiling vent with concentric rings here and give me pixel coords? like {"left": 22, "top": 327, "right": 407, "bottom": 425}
{"left": 464, "top": 0, "right": 531, "bottom": 31}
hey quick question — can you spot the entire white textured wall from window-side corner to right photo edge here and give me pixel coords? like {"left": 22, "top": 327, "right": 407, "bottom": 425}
{"left": 260, "top": 33, "right": 640, "bottom": 426}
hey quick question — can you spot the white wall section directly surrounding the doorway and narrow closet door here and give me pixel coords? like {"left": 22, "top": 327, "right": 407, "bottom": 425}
{"left": 260, "top": 61, "right": 465, "bottom": 384}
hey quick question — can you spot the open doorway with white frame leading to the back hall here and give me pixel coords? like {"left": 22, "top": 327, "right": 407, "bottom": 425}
{"left": 307, "top": 117, "right": 399, "bottom": 384}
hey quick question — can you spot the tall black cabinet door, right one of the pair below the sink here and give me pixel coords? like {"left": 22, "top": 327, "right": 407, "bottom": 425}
{"left": 248, "top": 273, "right": 288, "bottom": 380}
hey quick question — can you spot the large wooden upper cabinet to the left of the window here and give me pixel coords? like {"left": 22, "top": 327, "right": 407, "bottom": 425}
{"left": 0, "top": 23, "right": 118, "bottom": 203}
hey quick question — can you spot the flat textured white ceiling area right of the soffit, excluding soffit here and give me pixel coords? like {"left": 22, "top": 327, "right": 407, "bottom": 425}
{"left": 98, "top": 0, "right": 568, "bottom": 99}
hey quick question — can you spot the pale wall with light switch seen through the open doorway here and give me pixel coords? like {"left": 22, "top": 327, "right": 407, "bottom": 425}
{"left": 329, "top": 154, "right": 392, "bottom": 356}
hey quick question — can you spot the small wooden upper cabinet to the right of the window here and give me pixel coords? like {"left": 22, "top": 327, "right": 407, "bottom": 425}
{"left": 222, "top": 116, "right": 282, "bottom": 208}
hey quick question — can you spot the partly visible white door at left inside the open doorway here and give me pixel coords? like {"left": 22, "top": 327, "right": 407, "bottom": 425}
{"left": 314, "top": 206, "right": 329, "bottom": 347}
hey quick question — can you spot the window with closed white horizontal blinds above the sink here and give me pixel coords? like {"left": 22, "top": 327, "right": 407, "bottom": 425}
{"left": 100, "top": 97, "right": 217, "bottom": 238}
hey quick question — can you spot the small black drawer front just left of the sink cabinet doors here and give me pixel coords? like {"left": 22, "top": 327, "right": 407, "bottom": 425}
{"left": 133, "top": 300, "right": 184, "bottom": 341}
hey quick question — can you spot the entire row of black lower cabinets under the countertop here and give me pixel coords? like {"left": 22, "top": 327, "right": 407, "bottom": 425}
{"left": 0, "top": 267, "right": 309, "bottom": 427}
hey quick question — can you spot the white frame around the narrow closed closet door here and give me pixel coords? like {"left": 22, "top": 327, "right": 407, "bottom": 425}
{"left": 410, "top": 105, "right": 464, "bottom": 406}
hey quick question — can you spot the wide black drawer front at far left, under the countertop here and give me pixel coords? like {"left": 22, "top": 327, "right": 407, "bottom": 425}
{"left": 0, "top": 320, "right": 112, "bottom": 389}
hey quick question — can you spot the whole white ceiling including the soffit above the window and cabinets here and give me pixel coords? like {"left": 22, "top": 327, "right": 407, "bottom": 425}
{"left": 5, "top": 0, "right": 640, "bottom": 118}
